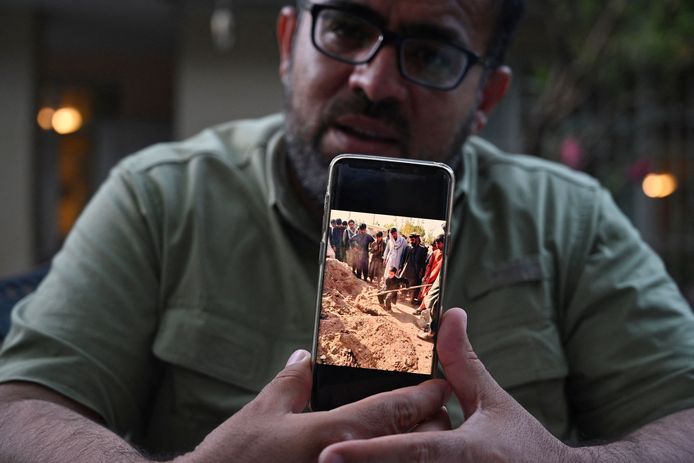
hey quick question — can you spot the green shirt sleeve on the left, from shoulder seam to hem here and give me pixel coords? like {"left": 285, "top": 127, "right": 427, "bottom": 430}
{"left": 0, "top": 168, "right": 159, "bottom": 440}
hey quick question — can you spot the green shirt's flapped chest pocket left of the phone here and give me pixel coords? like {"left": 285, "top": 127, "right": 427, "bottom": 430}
{"left": 153, "top": 307, "right": 299, "bottom": 428}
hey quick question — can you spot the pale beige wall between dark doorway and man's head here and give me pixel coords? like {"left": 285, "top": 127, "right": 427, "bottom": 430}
{"left": 174, "top": 7, "right": 282, "bottom": 138}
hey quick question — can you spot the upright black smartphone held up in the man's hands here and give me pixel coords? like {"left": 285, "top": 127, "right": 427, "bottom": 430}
{"left": 311, "top": 154, "right": 455, "bottom": 410}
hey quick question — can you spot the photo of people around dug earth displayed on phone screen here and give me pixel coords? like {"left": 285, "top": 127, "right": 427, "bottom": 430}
{"left": 317, "top": 210, "right": 446, "bottom": 374}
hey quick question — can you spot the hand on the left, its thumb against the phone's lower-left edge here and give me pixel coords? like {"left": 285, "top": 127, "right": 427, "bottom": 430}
{"left": 175, "top": 350, "right": 450, "bottom": 463}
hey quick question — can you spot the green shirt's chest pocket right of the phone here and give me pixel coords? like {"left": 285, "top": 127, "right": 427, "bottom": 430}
{"left": 465, "top": 255, "right": 568, "bottom": 389}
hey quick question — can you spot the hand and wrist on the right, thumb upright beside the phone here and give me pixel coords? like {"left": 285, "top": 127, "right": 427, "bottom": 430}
{"left": 319, "top": 309, "right": 694, "bottom": 463}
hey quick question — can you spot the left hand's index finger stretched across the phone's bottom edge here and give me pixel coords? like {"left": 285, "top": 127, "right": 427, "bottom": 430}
{"left": 329, "top": 380, "right": 451, "bottom": 439}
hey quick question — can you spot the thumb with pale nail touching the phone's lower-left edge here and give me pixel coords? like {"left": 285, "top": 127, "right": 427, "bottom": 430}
{"left": 256, "top": 349, "right": 312, "bottom": 413}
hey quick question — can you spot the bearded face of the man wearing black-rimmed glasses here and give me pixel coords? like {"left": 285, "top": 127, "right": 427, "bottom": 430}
{"left": 280, "top": 0, "right": 508, "bottom": 207}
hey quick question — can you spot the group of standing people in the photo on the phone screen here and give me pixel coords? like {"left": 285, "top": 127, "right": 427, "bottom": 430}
{"left": 328, "top": 218, "right": 445, "bottom": 331}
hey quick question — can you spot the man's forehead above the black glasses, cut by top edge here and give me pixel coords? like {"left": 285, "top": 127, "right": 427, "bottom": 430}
{"left": 317, "top": 0, "right": 497, "bottom": 52}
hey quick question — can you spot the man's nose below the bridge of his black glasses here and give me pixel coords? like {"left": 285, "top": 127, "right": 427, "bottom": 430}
{"left": 349, "top": 46, "right": 407, "bottom": 101}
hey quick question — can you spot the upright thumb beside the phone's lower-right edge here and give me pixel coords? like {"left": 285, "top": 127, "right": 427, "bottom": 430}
{"left": 436, "top": 308, "right": 499, "bottom": 417}
